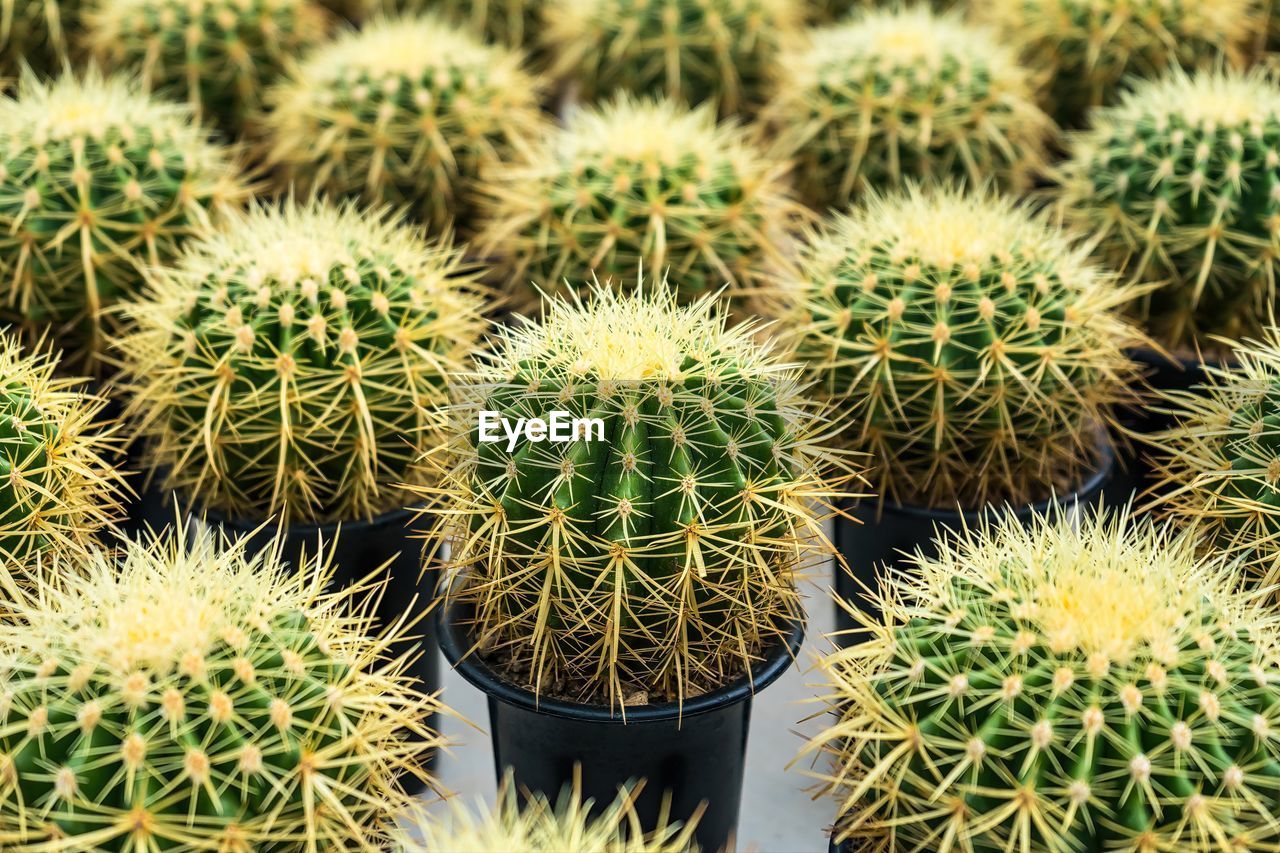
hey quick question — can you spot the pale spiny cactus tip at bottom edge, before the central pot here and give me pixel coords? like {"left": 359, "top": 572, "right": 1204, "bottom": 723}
{"left": 396, "top": 775, "right": 698, "bottom": 853}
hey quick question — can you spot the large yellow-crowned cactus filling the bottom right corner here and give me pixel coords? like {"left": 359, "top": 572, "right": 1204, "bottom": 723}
{"left": 810, "top": 507, "right": 1280, "bottom": 853}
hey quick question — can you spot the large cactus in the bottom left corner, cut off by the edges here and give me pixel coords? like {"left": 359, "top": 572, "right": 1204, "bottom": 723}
{"left": 0, "top": 522, "right": 439, "bottom": 853}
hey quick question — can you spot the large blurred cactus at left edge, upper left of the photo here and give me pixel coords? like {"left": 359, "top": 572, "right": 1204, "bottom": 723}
{"left": 0, "top": 72, "right": 243, "bottom": 361}
